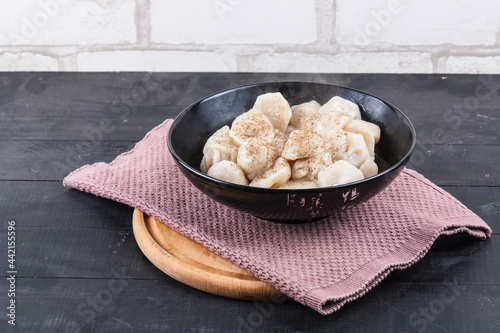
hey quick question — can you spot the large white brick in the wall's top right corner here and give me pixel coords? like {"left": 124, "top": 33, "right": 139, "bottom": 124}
{"left": 335, "top": 0, "right": 500, "bottom": 48}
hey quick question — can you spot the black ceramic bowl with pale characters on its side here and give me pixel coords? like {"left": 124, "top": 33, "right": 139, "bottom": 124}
{"left": 168, "top": 82, "right": 415, "bottom": 223}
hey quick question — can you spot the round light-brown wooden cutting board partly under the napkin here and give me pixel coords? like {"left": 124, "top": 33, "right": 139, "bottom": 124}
{"left": 133, "top": 209, "right": 286, "bottom": 301}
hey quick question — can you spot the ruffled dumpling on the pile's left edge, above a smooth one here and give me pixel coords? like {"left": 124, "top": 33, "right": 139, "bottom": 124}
{"left": 200, "top": 126, "right": 238, "bottom": 173}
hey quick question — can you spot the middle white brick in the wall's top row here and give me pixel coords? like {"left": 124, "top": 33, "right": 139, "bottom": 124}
{"left": 151, "top": 0, "right": 316, "bottom": 45}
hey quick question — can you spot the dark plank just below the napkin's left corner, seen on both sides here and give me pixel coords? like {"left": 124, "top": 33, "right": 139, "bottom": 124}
{"left": 0, "top": 181, "right": 500, "bottom": 233}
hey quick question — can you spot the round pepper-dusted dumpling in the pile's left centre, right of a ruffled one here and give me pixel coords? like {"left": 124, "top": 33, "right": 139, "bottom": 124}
{"left": 236, "top": 138, "right": 276, "bottom": 180}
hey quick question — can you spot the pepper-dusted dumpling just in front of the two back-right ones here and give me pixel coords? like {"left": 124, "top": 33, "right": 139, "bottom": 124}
{"left": 300, "top": 112, "right": 353, "bottom": 140}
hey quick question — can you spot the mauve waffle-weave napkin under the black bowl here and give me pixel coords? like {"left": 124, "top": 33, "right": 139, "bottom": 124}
{"left": 64, "top": 120, "right": 491, "bottom": 314}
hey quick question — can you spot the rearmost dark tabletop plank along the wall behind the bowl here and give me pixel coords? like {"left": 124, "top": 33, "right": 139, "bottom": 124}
{"left": 0, "top": 73, "right": 500, "bottom": 144}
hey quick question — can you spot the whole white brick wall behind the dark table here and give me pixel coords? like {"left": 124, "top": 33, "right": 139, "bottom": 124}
{"left": 0, "top": 0, "right": 500, "bottom": 73}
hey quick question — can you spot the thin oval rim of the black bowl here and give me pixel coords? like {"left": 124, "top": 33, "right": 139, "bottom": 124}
{"left": 167, "top": 80, "right": 417, "bottom": 194}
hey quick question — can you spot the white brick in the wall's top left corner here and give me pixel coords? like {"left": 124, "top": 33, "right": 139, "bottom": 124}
{"left": 0, "top": 0, "right": 136, "bottom": 46}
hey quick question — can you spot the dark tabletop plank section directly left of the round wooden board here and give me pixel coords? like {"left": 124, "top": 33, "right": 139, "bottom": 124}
{"left": 0, "top": 220, "right": 165, "bottom": 279}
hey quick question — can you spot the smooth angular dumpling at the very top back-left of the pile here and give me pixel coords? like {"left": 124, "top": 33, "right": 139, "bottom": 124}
{"left": 253, "top": 93, "right": 292, "bottom": 132}
